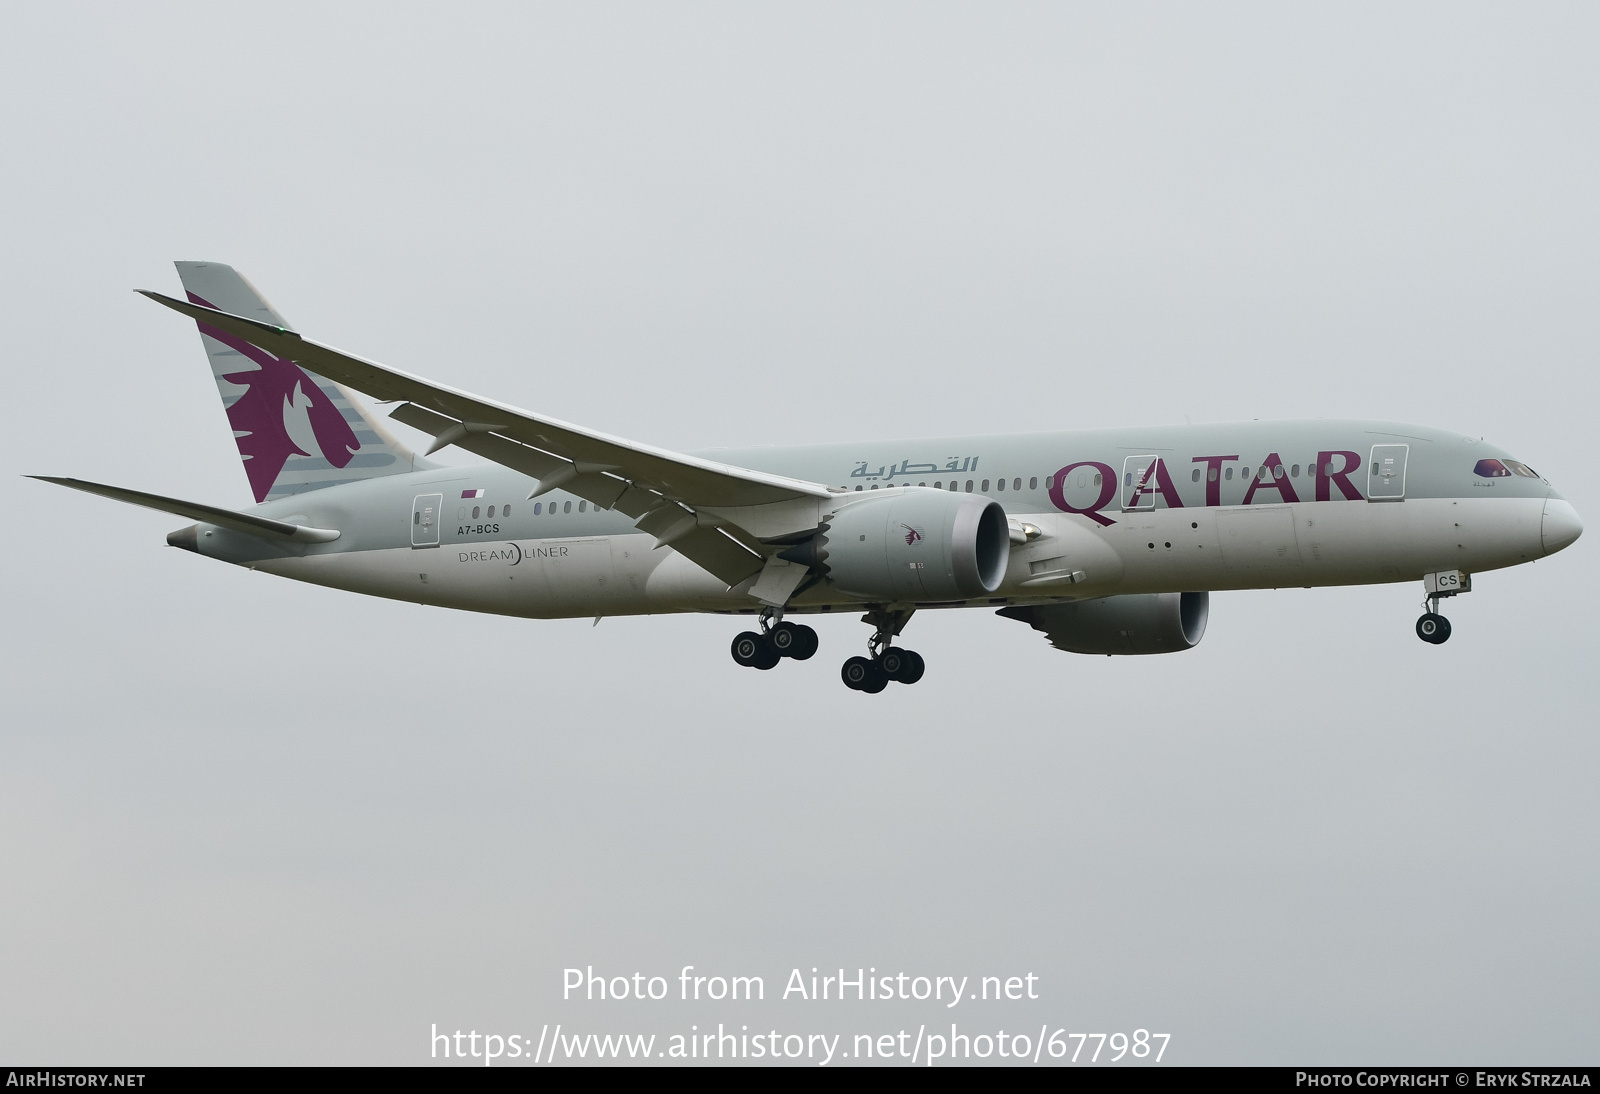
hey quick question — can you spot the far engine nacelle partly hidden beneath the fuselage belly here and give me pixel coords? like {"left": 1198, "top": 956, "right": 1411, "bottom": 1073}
{"left": 1000, "top": 593, "right": 1211, "bottom": 654}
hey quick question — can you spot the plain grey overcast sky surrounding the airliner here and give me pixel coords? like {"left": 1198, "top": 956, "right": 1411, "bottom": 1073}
{"left": 0, "top": 3, "right": 1600, "bottom": 1064}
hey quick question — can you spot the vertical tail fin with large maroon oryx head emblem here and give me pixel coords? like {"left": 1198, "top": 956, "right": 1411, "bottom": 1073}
{"left": 176, "top": 262, "right": 430, "bottom": 502}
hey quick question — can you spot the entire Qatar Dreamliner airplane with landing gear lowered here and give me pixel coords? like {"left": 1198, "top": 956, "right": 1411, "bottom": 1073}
{"left": 35, "top": 262, "right": 1582, "bottom": 694}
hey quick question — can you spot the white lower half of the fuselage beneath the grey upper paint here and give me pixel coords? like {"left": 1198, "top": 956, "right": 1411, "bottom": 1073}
{"left": 256, "top": 497, "right": 1546, "bottom": 619}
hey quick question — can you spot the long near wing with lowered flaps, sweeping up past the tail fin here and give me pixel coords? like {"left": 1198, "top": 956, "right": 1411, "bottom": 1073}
{"left": 141, "top": 289, "right": 832, "bottom": 585}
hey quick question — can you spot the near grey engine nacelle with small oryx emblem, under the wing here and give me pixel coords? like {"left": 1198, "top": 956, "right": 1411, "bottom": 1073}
{"left": 800, "top": 486, "right": 1011, "bottom": 603}
